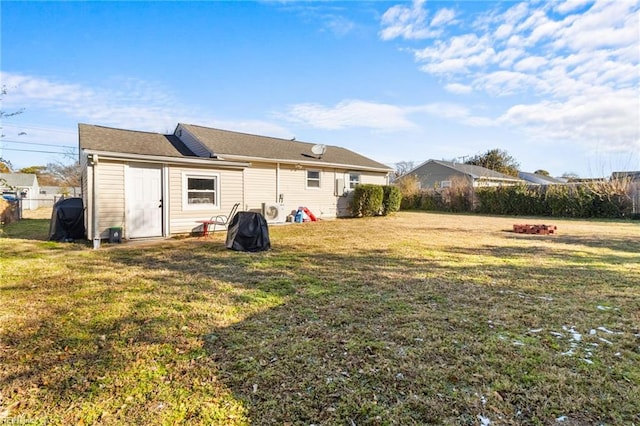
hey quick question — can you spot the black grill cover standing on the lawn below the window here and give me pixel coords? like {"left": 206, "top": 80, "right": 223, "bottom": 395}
{"left": 226, "top": 212, "right": 271, "bottom": 251}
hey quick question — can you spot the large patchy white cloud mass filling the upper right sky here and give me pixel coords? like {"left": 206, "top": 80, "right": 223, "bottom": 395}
{"left": 382, "top": 0, "right": 640, "bottom": 151}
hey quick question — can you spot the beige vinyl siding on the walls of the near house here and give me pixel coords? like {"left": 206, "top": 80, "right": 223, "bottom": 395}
{"left": 82, "top": 157, "right": 386, "bottom": 239}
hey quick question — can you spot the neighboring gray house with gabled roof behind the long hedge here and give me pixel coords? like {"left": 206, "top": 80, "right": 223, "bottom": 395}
{"left": 405, "top": 160, "right": 523, "bottom": 189}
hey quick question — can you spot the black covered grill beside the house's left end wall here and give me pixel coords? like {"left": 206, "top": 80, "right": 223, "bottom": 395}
{"left": 49, "top": 198, "right": 85, "bottom": 241}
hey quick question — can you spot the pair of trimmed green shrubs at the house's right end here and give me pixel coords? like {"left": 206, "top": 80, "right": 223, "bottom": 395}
{"left": 351, "top": 184, "right": 402, "bottom": 217}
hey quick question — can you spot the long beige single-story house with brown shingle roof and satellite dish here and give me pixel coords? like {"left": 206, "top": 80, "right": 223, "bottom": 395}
{"left": 79, "top": 123, "right": 392, "bottom": 246}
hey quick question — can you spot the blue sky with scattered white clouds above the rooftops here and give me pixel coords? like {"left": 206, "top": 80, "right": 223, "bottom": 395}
{"left": 0, "top": 0, "right": 640, "bottom": 177}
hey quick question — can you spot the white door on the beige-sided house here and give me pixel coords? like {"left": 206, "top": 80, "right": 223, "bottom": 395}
{"left": 126, "top": 166, "right": 162, "bottom": 238}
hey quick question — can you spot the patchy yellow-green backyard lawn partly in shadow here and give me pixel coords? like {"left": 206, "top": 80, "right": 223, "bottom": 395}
{"left": 0, "top": 212, "right": 640, "bottom": 425}
